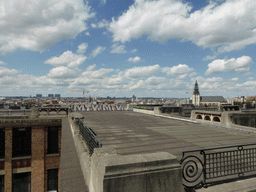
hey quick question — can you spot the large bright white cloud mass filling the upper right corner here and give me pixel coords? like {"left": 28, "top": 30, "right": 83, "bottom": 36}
{"left": 109, "top": 0, "right": 256, "bottom": 53}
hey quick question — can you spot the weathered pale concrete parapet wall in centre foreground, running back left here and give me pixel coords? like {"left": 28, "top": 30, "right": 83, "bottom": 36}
{"left": 70, "top": 112, "right": 184, "bottom": 192}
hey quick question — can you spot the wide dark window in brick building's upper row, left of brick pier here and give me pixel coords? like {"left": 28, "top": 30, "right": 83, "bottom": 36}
{"left": 12, "top": 127, "right": 31, "bottom": 157}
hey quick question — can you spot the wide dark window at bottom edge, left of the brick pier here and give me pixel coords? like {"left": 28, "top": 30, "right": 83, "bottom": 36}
{"left": 12, "top": 173, "right": 31, "bottom": 192}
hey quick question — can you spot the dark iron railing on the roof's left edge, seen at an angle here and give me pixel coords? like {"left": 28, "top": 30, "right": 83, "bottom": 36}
{"left": 78, "top": 119, "right": 102, "bottom": 156}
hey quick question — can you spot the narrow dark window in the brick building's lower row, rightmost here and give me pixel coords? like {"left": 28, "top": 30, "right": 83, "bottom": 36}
{"left": 47, "top": 169, "right": 59, "bottom": 192}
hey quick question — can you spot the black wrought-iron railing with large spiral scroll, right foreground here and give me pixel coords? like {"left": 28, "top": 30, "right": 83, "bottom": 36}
{"left": 180, "top": 143, "right": 256, "bottom": 188}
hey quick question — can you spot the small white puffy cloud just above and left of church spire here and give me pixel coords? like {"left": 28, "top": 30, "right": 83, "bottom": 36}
{"left": 162, "top": 64, "right": 194, "bottom": 78}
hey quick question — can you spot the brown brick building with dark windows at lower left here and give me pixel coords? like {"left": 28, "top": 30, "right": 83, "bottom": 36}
{"left": 0, "top": 117, "right": 62, "bottom": 192}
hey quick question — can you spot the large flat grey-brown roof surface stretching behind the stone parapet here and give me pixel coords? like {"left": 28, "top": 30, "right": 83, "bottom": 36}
{"left": 80, "top": 111, "right": 256, "bottom": 159}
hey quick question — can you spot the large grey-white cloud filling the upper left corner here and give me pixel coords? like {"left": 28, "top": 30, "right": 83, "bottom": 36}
{"left": 0, "top": 0, "right": 95, "bottom": 53}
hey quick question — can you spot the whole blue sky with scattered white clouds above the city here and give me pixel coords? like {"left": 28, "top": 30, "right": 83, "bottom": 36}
{"left": 0, "top": 0, "right": 256, "bottom": 98}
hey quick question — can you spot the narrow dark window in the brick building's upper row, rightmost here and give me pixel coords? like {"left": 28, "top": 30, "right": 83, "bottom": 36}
{"left": 48, "top": 127, "right": 59, "bottom": 154}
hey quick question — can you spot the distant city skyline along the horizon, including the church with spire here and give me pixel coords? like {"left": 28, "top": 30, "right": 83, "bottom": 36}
{"left": 0, "top": 81, "right": 256, "bottom": 109}
